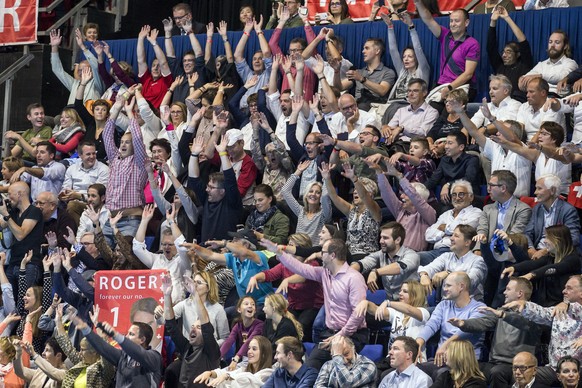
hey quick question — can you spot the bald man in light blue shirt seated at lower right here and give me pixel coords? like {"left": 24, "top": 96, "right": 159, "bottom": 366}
{"left": 416, "top": 272, "right": 486, "bottom": 380}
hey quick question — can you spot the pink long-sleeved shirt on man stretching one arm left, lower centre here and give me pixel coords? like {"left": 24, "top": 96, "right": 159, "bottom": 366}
{"left": 279, "top": 253, "right": 368, "bottom": 337}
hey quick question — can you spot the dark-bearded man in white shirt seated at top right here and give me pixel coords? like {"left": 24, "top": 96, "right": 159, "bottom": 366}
{"left": 519, "top": 30, "right": 578, "bottom": 94}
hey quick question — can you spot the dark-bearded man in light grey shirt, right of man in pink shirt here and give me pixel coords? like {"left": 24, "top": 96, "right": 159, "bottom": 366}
{"left": 351, "top": 221, "right": 419, "bottom": 300}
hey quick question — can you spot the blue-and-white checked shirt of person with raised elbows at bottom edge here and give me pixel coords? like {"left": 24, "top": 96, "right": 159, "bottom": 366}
{"left": 314, "top": 353, "right": 376, "bottom": 388}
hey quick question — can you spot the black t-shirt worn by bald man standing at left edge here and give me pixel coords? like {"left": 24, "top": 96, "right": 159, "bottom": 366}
{"left": 9, "top": 205, "right": 43, "bottom": 267}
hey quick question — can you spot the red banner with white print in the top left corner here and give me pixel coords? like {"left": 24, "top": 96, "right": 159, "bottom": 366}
{"left": 0, "top": 0, "right": 38, "bottom": 46}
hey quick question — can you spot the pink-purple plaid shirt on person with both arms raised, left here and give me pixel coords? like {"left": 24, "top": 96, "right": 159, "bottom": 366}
{"left": 103, "top": 119, "right": 148, "bottom": 211}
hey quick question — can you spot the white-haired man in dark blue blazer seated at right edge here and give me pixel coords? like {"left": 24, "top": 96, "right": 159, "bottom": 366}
{"left": 525, "top": 174, "right": 580, "bottom": 260}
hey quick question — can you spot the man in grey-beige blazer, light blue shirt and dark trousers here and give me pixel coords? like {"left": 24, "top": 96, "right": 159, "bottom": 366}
{"left": 477, "top": 170, "right": 531, "bottom": 307}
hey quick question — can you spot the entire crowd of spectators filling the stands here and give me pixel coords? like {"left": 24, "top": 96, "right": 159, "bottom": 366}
{"left": 0, "top": 0, "right": 582, "bottom": 388}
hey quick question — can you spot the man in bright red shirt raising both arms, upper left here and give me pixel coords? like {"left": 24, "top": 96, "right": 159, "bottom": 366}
{"left": 137, "top": 26, "right": 172, "bottom": 109}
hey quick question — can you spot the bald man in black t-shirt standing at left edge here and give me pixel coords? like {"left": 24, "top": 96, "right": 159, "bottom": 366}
{"left": 0, "top": 181, "right": 43, "bottom": 295}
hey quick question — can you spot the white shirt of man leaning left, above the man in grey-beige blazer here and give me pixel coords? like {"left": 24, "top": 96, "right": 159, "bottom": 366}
{"left": 483, "top": 138, "right": 531, "bottom": 198}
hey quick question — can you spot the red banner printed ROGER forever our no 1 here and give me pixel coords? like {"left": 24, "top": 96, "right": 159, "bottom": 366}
{"left": 94, "top": 270, "right": 166, "bottom": 347}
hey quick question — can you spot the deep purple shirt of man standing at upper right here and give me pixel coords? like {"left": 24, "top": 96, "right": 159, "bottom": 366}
{"left": 438, "top": 26, "right": 481, "bottom": 85}
